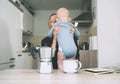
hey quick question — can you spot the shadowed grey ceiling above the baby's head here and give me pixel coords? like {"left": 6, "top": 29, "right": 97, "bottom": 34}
{"left": 22, "top": 0, "right": 87, "bottom": 10}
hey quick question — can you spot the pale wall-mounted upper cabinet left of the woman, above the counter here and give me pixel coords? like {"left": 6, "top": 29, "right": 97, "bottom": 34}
{"left": 20, "top": 4, "right": 34, "bottom": 34}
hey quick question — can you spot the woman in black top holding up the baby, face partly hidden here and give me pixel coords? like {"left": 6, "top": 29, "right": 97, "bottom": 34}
{"left": 41, "top": 13, "right": 61, "bottom": 69}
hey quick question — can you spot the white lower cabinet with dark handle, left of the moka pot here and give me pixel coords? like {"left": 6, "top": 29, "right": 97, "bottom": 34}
{"left": 15, "top": 53, "right": 33, "bottom": 69}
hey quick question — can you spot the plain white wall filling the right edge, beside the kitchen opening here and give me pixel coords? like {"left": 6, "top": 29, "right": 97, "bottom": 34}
{"left": 97, "top": 0, "right": 120, "bottom": 67}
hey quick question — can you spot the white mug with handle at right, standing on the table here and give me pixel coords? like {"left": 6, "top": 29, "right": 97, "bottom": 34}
{"left": 63, "top": 59, "right": 81, "bottom": 73}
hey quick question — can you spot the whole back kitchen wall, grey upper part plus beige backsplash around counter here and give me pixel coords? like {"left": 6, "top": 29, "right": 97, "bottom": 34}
{"left": 23, "top": 0, "right": 97, "bottom": 46}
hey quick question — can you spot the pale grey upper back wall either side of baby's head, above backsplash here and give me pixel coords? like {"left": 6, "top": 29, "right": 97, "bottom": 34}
{"left": 34, "top": 10, "right": 81, "bottom": 36}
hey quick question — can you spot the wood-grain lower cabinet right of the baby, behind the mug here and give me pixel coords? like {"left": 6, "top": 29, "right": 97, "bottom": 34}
{"left": 80, "top": 50, "right": 98, "bottom": 68}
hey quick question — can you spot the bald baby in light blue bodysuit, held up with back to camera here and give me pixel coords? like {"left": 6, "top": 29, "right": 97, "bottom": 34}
{"left": 48, "top": 8, "right": 80, "bottom": 58}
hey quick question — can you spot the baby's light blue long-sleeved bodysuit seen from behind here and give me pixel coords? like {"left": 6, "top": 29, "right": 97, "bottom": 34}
{"left": 48, "top": 21, "right": 80, "bottom": 58}
